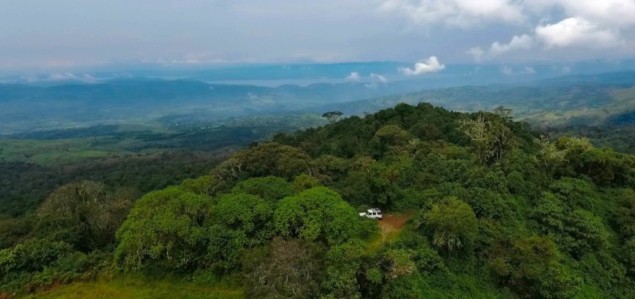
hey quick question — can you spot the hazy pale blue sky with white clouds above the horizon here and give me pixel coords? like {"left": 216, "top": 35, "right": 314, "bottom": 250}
{"left": 0, "top": 0, "right": 635, "bottom": 75}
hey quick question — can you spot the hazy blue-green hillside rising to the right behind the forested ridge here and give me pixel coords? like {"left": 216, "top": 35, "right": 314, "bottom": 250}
{"left": 323, "top": 72, "right": 635, "bottom": 127}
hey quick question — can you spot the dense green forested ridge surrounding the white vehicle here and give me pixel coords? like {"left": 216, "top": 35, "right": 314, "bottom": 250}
{"left": 0, "top": 103, "right": 635, "bottom": 298}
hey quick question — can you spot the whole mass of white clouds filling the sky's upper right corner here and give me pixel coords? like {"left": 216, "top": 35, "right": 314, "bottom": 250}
{"left": 380, "top": 0, "right": 635, "bottom": 62}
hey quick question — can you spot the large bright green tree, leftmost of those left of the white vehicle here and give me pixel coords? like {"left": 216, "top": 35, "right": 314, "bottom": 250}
{"left": 115, "top": 187, "right": 212, "bottom": 270}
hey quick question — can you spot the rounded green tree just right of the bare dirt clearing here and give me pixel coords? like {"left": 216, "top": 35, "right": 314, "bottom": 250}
{"left": 424, "top": 198, "right": 478, "bottom": 251}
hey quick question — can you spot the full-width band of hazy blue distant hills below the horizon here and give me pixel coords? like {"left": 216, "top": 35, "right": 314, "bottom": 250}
{"left": 0, "top": 71, "right": 635, "bottom": 134}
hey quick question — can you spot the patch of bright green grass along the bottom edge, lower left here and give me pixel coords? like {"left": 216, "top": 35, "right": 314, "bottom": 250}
{"left": 26, "top": 275, "right": 244, "bottom": 299}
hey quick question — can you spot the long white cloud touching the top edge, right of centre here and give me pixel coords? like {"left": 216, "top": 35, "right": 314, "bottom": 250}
{"left": 380, "top": 0, "right": 525, "bottom": 29}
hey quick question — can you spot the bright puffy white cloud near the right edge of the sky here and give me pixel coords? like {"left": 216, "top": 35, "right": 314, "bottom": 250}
{"left": 536, "top": 17, "right": 622, "bottom": 48}
